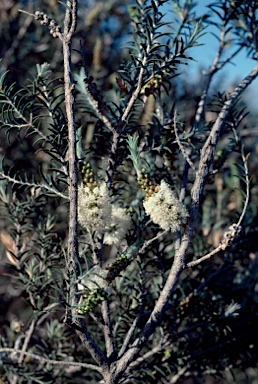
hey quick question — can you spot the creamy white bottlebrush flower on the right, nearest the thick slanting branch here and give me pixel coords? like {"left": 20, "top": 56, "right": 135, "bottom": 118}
{"left": 143, "top": 180, "right": 188, "bottom": 232}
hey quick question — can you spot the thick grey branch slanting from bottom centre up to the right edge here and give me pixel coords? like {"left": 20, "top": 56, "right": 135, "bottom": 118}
{"left": 111, "top": 65, "right": 258, "bottom": 375}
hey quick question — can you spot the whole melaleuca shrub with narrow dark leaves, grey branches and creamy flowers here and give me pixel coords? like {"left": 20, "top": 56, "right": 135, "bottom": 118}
{"left": 0, "top": 0, "right": 258, "bottom": 384}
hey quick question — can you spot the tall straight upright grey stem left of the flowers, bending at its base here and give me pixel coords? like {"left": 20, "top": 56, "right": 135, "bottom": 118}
{"left": 63, "top": 0, "right": 108, "bottom": 370}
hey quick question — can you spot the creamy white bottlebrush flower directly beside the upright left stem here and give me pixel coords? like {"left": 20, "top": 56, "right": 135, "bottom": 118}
{"left": 78, "top": 183, "right": 111, "bottom": 231}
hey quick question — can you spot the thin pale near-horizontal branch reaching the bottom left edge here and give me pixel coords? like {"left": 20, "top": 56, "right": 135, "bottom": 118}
{"left": 0, "top": 348, "right": 101, "bottom": 372}
